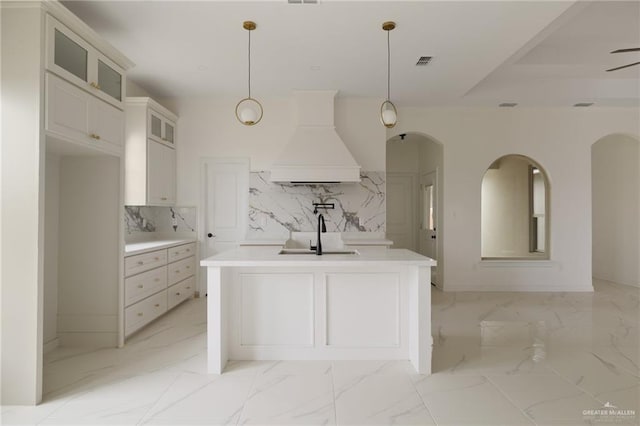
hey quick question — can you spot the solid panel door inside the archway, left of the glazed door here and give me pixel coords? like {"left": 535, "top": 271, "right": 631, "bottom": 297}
{"left": 387, "top": 173, "right": 416, "bottom": 250}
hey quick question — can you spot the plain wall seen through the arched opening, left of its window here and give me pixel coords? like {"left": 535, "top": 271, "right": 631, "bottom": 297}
{"left": 481, "top": 156, "right": 530, "bottom": 257}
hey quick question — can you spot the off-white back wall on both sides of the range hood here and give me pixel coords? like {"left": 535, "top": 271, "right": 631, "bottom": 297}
{"left": 165, "top": 95, "right": 386, "bottom": 206}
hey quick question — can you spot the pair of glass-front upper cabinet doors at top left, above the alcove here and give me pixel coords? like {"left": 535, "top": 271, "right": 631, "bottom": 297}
{"left": 46, "top": 15, "right": 125, "bottom": 109}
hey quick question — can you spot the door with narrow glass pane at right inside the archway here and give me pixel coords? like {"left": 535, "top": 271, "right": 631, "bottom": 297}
{"left": 418, "top": 170, "right": 438, "bottom": 285}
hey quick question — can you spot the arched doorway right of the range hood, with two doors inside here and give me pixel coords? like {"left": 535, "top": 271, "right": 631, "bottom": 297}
{"left": 386, "top": 133, "right": 444, "bottom": 288}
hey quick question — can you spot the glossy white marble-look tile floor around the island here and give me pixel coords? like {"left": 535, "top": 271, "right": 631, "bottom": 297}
{"left": 5, "top": 281, "right": 640, "bottom": 426}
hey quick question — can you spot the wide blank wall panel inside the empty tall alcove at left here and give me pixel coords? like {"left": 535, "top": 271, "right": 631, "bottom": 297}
{"left": 58, "top": 155, "right": 124, "bottom": 347}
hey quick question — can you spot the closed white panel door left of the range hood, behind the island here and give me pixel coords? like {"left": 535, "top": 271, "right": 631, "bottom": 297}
{"left": 198, "top": 158, "right": 249, "bottom": 289}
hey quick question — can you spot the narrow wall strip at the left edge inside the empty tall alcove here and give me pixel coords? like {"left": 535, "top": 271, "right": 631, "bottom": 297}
{"left": 43, "top": 152, "right": 60, "bottom": 352}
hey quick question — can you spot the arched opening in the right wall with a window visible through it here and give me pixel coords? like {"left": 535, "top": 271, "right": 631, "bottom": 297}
{"left": 481, "top": 154, "right": 549, "bottom": 260}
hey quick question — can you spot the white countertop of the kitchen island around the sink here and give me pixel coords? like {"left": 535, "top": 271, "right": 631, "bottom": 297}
{"left": 200, "top": 246, "right": 436, "bottom": 267}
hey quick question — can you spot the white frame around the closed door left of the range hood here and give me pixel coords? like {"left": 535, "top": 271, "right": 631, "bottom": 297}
{"left": 197, "top": 157, "right": 251, "bottom": 295}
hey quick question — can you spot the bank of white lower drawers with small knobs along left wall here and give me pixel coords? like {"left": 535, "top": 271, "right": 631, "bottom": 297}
{"left": 124, "top": 243, "right": 196, "bottom": 337}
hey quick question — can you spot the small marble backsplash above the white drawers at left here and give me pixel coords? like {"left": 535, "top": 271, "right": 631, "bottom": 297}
{"left": 124, "top": 206, "right": 197, "bottom": 235}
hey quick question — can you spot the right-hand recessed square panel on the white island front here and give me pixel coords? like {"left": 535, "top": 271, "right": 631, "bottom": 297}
{"left": 326, "top": 273, "right": 406, "bottom": 348}
